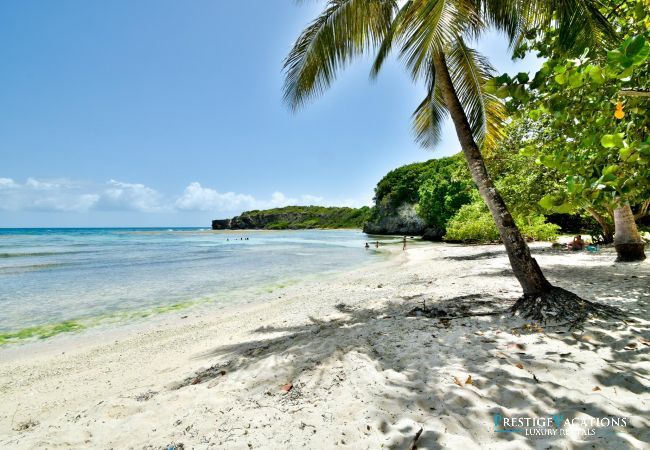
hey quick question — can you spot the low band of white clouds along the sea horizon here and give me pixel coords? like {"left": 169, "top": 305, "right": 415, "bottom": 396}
{"left": 0, "top": 177, "right": 370, "bottom": 214}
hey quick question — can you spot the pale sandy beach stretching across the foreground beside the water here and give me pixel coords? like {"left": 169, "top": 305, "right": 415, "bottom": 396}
{"left": 0, "top": 243, "right": 650, "bottom": 449}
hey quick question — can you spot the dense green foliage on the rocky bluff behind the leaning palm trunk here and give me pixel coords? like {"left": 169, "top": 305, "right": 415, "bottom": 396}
{"left": 374, "top": 134, "right": 560, "bottom": 242}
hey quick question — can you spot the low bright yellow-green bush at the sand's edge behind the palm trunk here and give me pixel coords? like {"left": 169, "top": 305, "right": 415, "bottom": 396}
{"left": 445, "top": 198, "right": 560, "bottom": 243}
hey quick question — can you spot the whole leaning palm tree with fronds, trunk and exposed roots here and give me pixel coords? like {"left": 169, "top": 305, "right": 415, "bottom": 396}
{"left": 284, "top": 0, "right": 615, "bottom": 324}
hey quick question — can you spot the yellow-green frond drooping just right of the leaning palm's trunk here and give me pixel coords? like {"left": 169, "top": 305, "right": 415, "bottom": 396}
{"left": 447, "top": 37, "right": 506, "bottom": 150}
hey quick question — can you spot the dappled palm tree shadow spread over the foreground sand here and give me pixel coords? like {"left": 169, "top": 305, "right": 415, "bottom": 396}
{"left": 174, "top": 267, "right": 650, "bottom": 449}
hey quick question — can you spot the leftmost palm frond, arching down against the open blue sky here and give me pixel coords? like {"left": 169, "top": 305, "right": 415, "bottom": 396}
{"left": 284, "top": 0, "right": 397, "bottom": 109}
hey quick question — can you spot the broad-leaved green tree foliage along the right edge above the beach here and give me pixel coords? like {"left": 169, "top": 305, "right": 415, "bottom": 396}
{"left": 488, "top": 0, "right": 650, "bottom": 239}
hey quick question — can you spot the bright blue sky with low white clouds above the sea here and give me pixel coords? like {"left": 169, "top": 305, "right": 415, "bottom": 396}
{"left": 0, "top": 0, "right": 540, "bottom": 227}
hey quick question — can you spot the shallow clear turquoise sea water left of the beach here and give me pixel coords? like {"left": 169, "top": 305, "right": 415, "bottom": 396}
{"left": 0, "top": 228, "right": 378, "bottom": 344}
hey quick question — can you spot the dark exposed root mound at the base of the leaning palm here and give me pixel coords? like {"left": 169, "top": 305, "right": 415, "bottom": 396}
{"left": 510, "top": 286, "right": 625, "bottom": 330}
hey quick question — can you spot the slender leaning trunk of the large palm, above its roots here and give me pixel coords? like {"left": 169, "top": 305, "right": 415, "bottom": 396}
{"left": 433, "top": 53, "right": 553, "bottom": 296}
